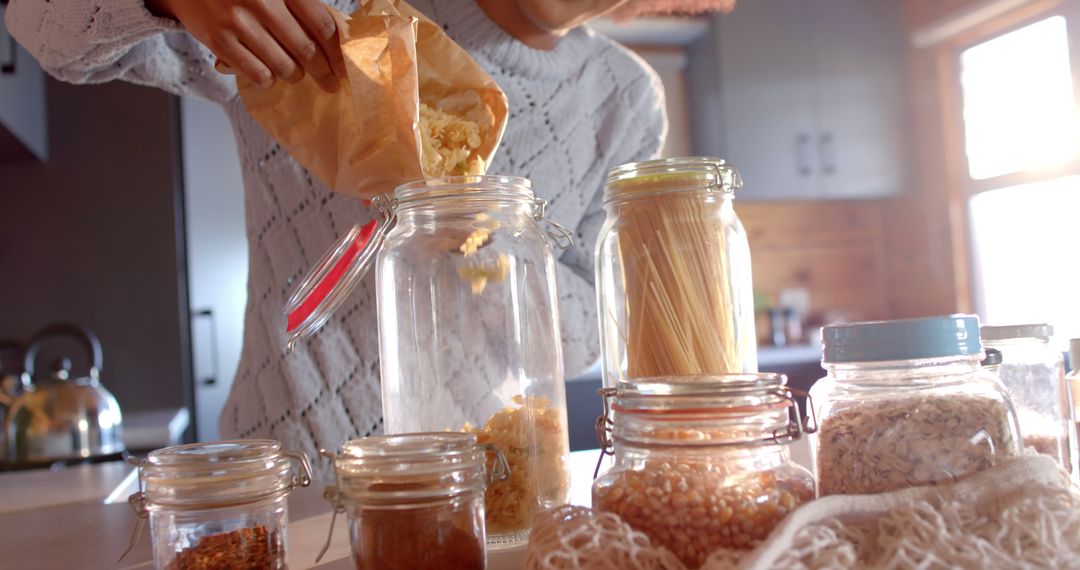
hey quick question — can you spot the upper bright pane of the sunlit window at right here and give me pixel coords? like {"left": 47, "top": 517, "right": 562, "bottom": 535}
{"left": 960, "top": 16, "right": 1078, "bottom": 180}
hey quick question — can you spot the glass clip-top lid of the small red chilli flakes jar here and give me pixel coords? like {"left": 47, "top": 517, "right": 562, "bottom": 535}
{"left": 136, "top": 439, "right": 311, "bottom": 510}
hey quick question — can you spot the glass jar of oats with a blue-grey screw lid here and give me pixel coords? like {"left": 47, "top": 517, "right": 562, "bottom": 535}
{"left": 810, "top": 315, "right": 1021, "bottom": 497}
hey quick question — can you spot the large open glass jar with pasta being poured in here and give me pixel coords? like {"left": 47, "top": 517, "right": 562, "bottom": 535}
{"left": 286, "top": 176, "right": 569, "bottom": 545}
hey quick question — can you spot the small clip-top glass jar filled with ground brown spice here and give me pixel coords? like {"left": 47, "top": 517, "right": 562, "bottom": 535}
{"left": 325, "top": 432, "right": 510, "bottom": 570}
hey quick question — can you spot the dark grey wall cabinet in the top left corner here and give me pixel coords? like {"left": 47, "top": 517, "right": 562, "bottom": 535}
{"left": 0, "top": 2, "right": 49, "bottom": 162}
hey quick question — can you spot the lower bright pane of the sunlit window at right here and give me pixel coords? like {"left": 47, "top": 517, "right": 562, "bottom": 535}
{"left": 970, "top": 176, "right": 1080, "bottom": 339}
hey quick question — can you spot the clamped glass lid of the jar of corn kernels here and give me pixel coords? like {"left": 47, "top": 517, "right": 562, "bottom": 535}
{"left": 598, "top": 374, "right": 813, "bottom": 447}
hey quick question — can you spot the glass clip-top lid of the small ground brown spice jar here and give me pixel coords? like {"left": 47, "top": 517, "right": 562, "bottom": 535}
{"left": 325, "top": 432, "right": 510, "bottom": 504}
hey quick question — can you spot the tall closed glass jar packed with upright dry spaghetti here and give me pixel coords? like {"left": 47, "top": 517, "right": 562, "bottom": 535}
{"left": 596, "top": 158, "right": 757, "bottom": 388}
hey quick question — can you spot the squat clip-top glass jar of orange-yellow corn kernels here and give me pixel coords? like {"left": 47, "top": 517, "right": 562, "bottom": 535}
{"left": 593, "top": 374, "right": 813, "bottom": 568}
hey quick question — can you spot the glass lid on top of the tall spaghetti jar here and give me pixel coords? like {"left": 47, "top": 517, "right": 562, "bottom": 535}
{"left": 604, "top": 157, "right": 742, "bottom": 203}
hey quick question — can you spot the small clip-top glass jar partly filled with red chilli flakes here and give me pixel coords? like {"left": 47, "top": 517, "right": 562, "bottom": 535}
{"left": 129, "top": 439, "right": 311, "bottom": 570}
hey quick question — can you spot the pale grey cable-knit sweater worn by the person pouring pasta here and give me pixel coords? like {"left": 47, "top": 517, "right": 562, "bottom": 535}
{"left": 6, "top": 0, "right": 666, "bottom": 475}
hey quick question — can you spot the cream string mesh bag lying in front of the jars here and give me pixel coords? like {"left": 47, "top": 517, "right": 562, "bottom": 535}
{"left": 525, "top": 456, "right": 1080, "bottom": 570}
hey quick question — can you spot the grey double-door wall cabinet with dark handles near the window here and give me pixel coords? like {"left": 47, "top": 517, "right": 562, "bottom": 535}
{"left": 689, "top": 0, "right": 907, "bottom": 200}
